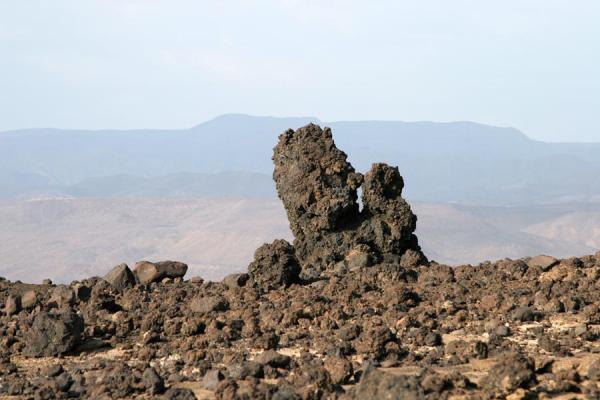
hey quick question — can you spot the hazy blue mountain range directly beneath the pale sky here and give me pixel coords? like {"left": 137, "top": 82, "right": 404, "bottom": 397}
{"left": 0, "top": 114, "right": 600, "bottom": 205}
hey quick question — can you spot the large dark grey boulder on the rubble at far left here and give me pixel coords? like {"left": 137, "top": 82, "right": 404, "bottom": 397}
{"left": 23, "top": 309, "right": 83, "bottom": 357}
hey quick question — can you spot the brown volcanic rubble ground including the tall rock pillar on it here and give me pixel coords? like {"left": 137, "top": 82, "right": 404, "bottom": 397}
{"left": 0, "top": 125, "right": 600, "bottom": 400}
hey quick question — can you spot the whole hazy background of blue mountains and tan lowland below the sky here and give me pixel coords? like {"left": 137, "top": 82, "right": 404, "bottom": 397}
{"left": 0, "top": 114, "right": 600, "bottom": 283}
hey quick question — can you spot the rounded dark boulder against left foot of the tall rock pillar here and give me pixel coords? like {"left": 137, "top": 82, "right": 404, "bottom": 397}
{"left": 248, "top": 239, "right": 300, "bottom": 291}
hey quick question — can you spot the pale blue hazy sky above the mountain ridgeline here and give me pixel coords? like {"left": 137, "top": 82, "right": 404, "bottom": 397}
{"left": 0, "top": 0, "right": 600, "bottom": 142}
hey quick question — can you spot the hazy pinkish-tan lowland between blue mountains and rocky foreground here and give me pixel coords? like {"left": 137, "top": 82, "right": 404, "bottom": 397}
{"left": 0, "top": 197, "right": 600, "bottom": 282}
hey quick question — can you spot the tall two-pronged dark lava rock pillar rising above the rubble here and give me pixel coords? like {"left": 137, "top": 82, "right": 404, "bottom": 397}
{"left": 273, "top": 124, "right": 426, "bottom": 273}
